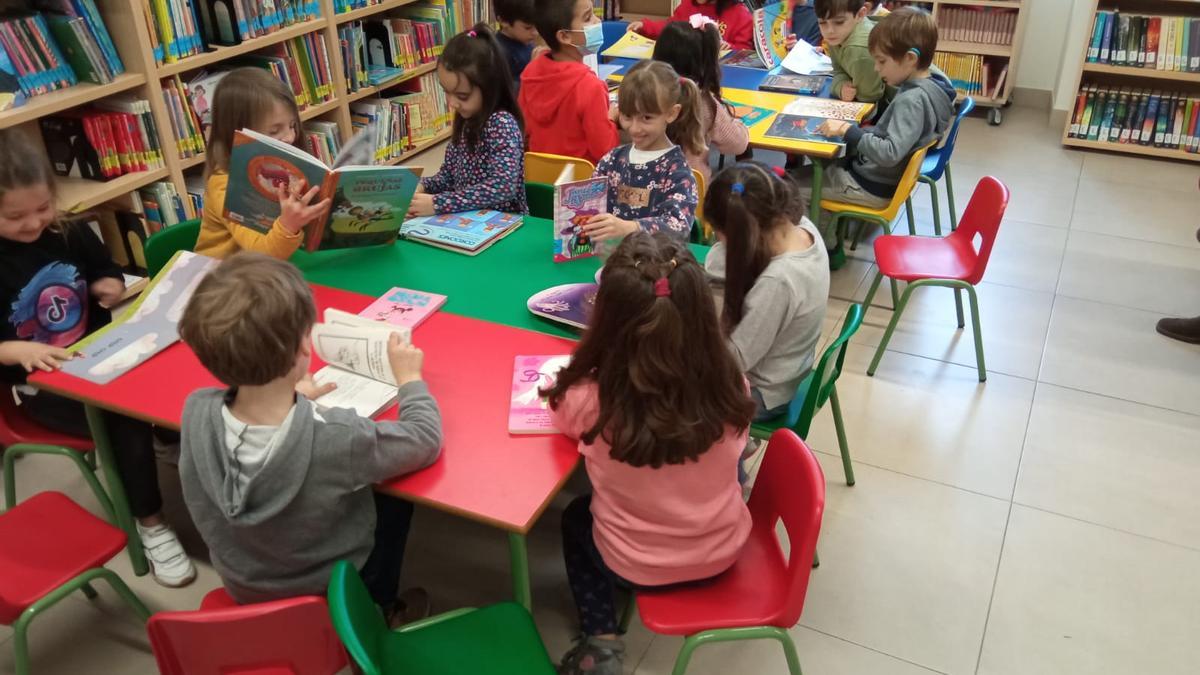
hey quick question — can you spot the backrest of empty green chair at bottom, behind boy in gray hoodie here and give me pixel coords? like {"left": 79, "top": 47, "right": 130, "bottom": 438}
{"left": 326, "top": 560, "right": 388, "bottom": 675}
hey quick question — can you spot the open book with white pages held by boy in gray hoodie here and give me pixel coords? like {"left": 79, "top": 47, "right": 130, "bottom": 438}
{"left": 312, "top": 309, "right": 412, "bottom": 417}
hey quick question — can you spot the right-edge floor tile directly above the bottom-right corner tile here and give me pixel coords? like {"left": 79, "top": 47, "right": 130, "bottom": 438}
{"left": 1014, "top": 383, "right": 1200, "bottom": 550}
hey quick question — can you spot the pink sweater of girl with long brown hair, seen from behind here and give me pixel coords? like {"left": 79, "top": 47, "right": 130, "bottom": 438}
{"left": 551, "top": 383, "right": 750, "bottom": 586}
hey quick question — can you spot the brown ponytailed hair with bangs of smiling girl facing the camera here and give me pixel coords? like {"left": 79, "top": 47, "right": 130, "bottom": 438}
{"left": 617, "top": 59, "right": 708, "bottom": 155}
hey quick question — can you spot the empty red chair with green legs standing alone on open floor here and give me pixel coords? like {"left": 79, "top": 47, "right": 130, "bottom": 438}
{"left": 863, "top": 175, "right": 1009, "bottom": 382}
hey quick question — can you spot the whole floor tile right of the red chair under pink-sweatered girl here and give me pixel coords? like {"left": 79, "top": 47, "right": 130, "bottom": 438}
{"left": 800, "top": 454, "right": 1008, "bottom": 674}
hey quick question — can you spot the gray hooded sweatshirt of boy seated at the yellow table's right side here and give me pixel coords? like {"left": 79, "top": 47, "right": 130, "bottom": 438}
{"left": 846, "top": 71, "right": 955, "bottom": 198}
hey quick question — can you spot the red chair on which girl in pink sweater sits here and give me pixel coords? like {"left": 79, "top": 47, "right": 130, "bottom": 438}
{"left": 636, "top": 429, "right": 824, "bottom": 675}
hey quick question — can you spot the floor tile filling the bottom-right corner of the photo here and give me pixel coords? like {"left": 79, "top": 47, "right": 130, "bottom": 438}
{"left": 979, "top": 506, "right": 1200, "bottom": 675}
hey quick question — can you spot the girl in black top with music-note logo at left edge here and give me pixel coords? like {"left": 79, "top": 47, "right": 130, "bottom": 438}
{"left": 0, "top": 129, "right": 196, "bottom": 587}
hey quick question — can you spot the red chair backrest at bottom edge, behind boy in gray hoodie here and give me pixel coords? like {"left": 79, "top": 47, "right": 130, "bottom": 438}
{"left": 146, "top": 596, "right": 348, "bottom": 675}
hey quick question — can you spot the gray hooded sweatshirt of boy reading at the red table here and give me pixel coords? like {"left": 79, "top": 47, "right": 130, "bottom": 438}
{"left": 179, "top": 382, "right": 442, "bottom": 603}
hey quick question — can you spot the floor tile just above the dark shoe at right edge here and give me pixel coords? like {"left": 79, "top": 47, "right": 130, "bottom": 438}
{"left": 1058, "top": 231, "right": 1200, "bottom": 316}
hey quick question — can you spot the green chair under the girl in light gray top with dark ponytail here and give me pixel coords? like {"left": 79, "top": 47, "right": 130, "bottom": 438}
{"left": 750, "top": 304, "right": 863, "bottom": 485}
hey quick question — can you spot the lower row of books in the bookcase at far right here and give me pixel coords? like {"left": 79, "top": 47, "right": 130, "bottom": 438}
{"left": 1067, "top": 85, "right": 1200, "bottom": 153}
